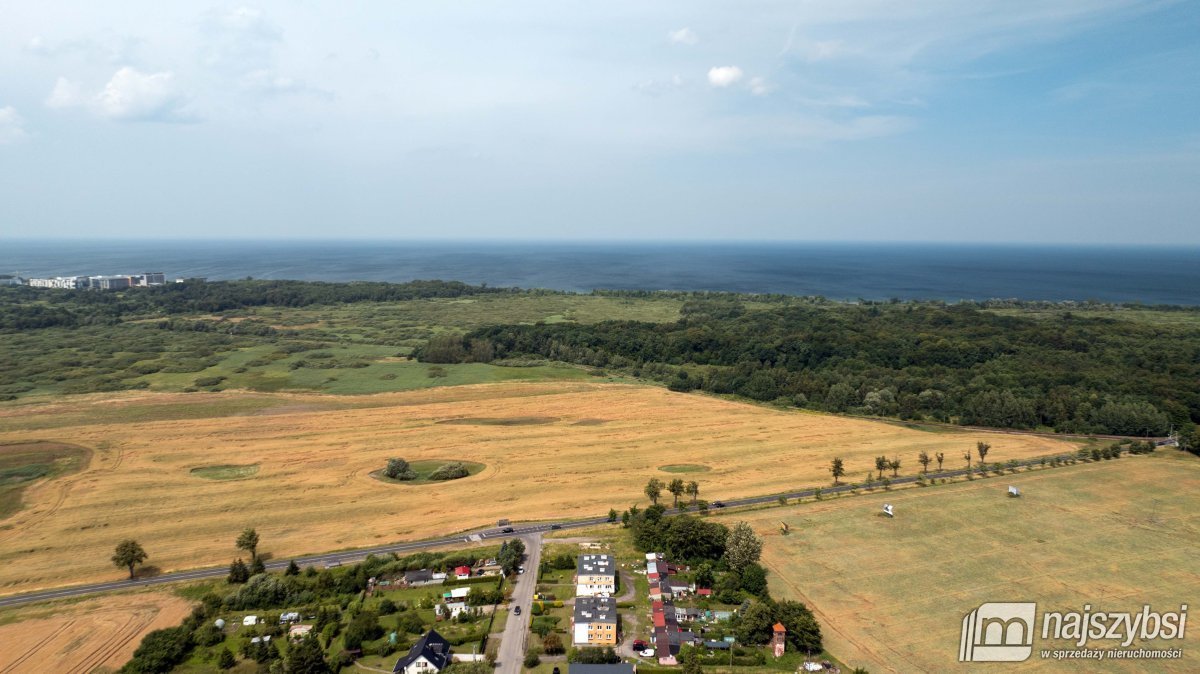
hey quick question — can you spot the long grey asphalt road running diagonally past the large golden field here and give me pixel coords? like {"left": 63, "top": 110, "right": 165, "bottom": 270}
{"left": 0, "top": 455, "right": 1074, "bottom": 609}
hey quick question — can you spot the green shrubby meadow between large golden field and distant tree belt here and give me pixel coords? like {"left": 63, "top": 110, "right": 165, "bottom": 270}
{"left": 0, "top": 293, "right": 683, "bottom": 401}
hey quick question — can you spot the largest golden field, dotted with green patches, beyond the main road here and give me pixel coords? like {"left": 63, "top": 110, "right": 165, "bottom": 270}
{"left": 0, "top": 383, "right": 1073, "bottom": 594}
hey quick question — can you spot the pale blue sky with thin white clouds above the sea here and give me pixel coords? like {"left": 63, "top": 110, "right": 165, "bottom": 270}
{"left": 0, "top": 0, "right": 1200, "bottom": 245}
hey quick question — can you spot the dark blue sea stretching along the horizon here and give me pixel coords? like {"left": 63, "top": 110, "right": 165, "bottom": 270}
{"left": 0, "top": 240, "right": 1200, "bottom": 306}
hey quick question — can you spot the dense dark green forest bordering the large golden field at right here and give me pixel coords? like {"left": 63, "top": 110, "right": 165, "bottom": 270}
{"left": 432, "top": 300, "right": 1200, "bottom": 435}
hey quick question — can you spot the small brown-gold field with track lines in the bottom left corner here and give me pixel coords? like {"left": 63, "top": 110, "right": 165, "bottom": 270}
{"left": 0, "top": 592, "right": 192, "bottom": 674}
